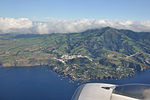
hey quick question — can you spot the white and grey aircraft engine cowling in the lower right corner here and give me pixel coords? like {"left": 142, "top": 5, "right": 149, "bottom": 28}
{"left": 72, "top": 83, "right": 150, "bottom": 100}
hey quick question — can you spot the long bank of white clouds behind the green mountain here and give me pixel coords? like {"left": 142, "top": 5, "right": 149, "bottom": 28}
{"left": 0, "top": 18, "right": 150, "bottom": 34}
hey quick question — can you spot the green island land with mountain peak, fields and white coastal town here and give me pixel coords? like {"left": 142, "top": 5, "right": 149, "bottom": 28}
{"left": 0, "top": 27, "right": 150, "bottom": 80}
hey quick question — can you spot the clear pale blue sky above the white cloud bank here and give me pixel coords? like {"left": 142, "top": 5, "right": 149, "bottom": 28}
{"left": 0, "top": 0, "right": 150, "bottom": 21}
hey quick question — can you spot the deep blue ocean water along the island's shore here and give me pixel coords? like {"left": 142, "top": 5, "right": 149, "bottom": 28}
{"left": 0, "top": 66, "right": 150, "bottom": 100}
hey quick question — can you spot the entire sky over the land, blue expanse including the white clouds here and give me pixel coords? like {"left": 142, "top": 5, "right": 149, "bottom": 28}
{"left": 0, "top": 0, "right": 150, "bottom": 34}
